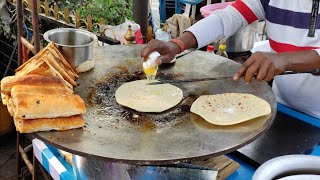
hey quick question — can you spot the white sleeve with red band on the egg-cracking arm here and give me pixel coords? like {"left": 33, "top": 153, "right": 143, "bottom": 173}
{"left": 186, "top": 0, "right": 265, "bottom": 48}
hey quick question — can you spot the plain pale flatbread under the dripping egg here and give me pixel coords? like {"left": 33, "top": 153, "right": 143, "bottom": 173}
{"left": 115, "top": 80, "right": 183, "bottom": 112}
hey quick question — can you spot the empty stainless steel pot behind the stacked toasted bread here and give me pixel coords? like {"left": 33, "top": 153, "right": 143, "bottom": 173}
{"left": 43, "top": 28, "right": 97, "bottom": 67}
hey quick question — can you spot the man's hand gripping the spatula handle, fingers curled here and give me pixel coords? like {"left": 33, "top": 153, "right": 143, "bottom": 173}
{"left": 233, "top": 52, "right": 288, "bottom": 82}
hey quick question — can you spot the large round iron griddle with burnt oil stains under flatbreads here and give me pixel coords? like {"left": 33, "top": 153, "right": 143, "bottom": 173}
{"left": 36, "top": 45, "right": 276, "bottom": 165}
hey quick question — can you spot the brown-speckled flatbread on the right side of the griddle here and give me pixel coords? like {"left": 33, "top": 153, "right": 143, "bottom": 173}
{"left": 190, "top": 93, "right": 271, "bottom": 125}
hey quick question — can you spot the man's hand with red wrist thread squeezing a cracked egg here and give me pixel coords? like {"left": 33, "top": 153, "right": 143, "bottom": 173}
{"left": 141, "top": 39, "right": 180, "bottom": 65}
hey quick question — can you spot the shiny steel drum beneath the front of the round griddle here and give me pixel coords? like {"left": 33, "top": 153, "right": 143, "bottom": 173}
{"left": 72, "top": 155, "right": 218, "bottom": 180}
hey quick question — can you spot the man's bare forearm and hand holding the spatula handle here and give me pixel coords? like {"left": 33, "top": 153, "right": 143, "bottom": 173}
{"left": 234, "top": 50, "right": 320, "bottom": 82}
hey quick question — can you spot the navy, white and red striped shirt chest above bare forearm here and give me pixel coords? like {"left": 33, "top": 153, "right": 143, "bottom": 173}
{"left": 264, "top": 0, "right": 320, "bottom": 52}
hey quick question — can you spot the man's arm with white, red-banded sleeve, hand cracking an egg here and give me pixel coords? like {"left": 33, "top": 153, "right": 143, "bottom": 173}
{"left": 141, "top": 0, "right": 265, "bottom": 64}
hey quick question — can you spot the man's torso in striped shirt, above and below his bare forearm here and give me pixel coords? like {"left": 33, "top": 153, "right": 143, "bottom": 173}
{"left": 264, "top": 0, "right": 320, "bottom": 118}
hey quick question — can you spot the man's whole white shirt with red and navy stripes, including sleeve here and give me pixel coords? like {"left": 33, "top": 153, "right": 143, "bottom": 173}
{"left": 187, "top": 0, "right": 320, "bottom": 118}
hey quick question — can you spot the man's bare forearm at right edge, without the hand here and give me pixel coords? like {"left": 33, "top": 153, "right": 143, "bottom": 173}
{"left": 279, "top": 50, "right": 320, "bottom": 72}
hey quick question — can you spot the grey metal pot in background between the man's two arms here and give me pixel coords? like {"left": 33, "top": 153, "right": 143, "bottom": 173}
{"left": 227, "top": 21, "right": 258, "bottom": 53}
